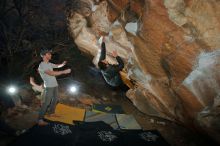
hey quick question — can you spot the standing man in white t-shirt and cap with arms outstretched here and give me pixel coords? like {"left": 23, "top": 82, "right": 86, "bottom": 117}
{"left": 38, "top": 49, "right": 71, "bottom": 126}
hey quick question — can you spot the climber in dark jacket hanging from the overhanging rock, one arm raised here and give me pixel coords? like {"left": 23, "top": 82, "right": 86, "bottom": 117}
{"left": 98, "top": 37, "right": 124, "bottom": 88}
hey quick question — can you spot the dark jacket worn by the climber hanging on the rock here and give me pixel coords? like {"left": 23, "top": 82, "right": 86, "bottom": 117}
{"left": 98, "top": 42, "right": 124, "bottom": 87}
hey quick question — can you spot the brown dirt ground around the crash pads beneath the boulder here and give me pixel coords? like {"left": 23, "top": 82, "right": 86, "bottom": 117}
{"left": 0, "top": 77, "right": 218, "bottom": 146}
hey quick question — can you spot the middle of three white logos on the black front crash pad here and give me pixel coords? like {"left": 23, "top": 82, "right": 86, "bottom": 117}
{"left": 97, "top": 131, "right": 117, "bottom": 142}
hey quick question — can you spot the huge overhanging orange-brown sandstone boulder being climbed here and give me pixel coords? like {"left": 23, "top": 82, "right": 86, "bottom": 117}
{"left": 67, "top": 0, "right": 220, "bottom": 142}
